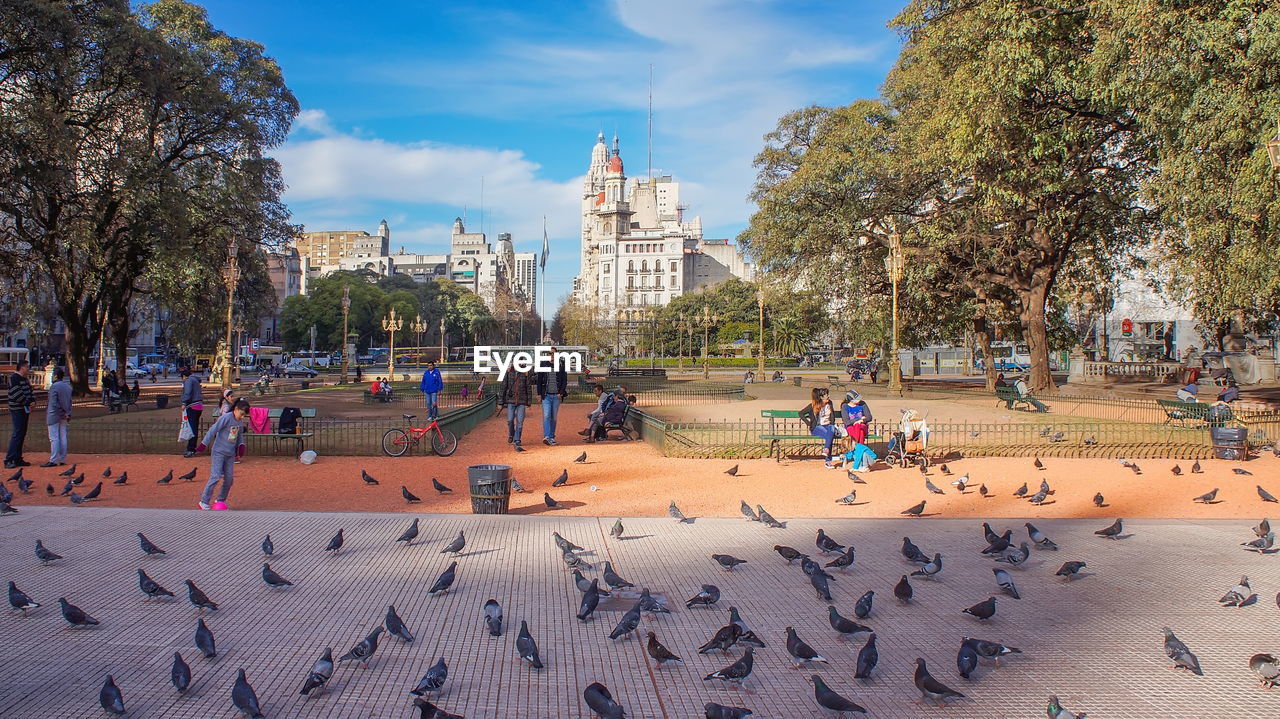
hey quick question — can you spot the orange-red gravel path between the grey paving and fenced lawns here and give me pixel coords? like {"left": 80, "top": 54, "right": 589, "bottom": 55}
{"left": 5, "top": 404, "right": 1280, "bottom": 521}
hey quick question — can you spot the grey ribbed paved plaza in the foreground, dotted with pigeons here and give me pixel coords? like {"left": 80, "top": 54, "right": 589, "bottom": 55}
{"left": 0, "top": 507, "right": 1280, "bottom": 719}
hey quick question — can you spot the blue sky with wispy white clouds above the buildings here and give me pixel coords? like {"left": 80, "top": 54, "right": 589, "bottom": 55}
{"left": 197, "top": 0, "right": 900, "bottom": 308}
